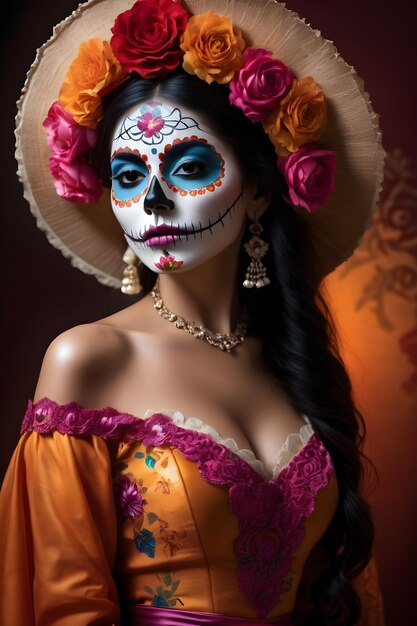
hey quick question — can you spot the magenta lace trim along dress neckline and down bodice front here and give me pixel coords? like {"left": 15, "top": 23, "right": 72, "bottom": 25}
{"left": 21, "top": 398, "right": 333, "bottom": 619}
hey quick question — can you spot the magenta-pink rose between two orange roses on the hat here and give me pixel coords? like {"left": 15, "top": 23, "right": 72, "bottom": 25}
{"left": 229, "top": 48, "right": 294, "bottom": 122}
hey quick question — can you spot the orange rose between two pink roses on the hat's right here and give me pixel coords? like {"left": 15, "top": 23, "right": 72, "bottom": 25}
{"left": 264, "top": 76, "right": 327, "bottom": 156}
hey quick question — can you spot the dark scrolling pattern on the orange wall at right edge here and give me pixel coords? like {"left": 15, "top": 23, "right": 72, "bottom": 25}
{"left": 338, "top": 150, "right": 417, "bottom": 394}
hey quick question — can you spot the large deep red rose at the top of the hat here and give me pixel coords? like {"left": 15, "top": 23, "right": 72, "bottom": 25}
{"left": 110, "top": 0, "right": 188, "bottom": 78}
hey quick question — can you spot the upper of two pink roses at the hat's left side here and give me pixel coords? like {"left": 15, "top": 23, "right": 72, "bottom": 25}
{"left": 43, "top": 102, "right": 96, "bottom": 161}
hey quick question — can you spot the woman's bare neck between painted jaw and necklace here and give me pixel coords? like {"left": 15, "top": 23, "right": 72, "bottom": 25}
{"left": 155, "top": 241, "right": 240, "bottom": 333}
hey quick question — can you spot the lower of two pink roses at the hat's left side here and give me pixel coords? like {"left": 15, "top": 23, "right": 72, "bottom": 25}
{"left": 49, "top": 156, "right": 102, "bottom": 204}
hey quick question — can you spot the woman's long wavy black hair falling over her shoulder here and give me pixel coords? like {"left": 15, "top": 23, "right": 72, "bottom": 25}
{"left": 93, "top": 70, "right": 374, "bottom": 626}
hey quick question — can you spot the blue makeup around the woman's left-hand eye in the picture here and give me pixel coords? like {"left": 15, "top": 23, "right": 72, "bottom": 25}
{"left": 111, "top": 153, "right": 149, "bottom": 200}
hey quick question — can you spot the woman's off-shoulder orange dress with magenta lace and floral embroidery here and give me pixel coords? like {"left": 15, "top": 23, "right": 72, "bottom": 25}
{"left": 0, "top": 398, "right": 382, "bottom": 626}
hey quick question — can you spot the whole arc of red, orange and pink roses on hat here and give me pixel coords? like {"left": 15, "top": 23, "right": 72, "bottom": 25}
{"left": 43, "top": 0, "right": 336, "bottom": 213}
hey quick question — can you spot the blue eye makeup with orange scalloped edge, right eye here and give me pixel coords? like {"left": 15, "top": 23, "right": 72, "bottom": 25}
{"left": 163, "top": 141, "right": 222, "bottom": 191}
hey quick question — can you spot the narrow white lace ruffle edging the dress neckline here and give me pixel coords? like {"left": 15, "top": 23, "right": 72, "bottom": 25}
{"left": 143, "top": 409, "right": 314, "bottom": 479}
